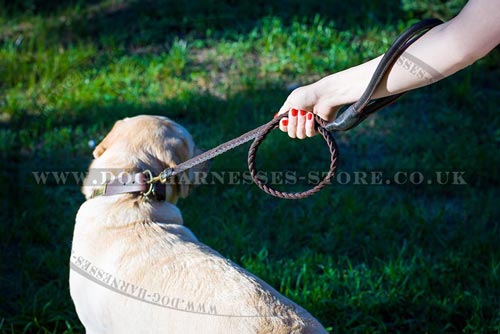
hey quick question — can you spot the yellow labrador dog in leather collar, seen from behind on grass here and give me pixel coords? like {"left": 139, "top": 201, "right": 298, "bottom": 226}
{"left": 70, "top": 116, "right": 326, "bottom": 334}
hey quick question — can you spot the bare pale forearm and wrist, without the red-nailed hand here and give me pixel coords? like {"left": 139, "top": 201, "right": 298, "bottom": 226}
{"left": 311, "top": 0, "right": 500, "bottom": 105}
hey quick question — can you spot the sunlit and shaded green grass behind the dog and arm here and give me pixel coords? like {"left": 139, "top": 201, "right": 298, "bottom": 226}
{"left": 0, "top": 0, "right": 500, "bottom": 333}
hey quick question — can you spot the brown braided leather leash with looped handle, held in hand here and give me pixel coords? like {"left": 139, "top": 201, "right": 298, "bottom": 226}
{"left": 148, "top": 19, "right": 442, "bottom": 199}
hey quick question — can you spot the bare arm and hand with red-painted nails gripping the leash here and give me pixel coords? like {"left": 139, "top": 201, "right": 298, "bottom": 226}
{"left": 279, "top": 0, "right": 500, "bottom": 138}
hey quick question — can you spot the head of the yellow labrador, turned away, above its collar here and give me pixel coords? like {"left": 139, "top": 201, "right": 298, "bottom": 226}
{"left": 82, "top": 115, "right": 208, "bottom": 204}
